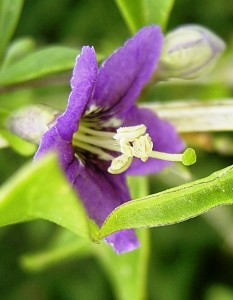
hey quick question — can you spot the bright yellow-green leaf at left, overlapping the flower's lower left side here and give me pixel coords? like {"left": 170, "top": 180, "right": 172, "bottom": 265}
{"left": 0, "top": 155, "right": 89, "bottom": 238}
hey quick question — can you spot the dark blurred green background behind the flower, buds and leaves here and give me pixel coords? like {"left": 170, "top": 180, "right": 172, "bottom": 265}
{"left": 0, "top": 0, "right": 233, "bottom": 300}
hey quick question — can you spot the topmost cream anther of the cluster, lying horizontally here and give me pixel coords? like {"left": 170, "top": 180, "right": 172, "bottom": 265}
{"left": 113, "top": 124, "right": 146, "bottom": 142}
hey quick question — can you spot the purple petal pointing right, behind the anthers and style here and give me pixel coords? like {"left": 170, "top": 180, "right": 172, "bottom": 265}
{"left": 122, "top": 106, "right": 184, "bottom": 175}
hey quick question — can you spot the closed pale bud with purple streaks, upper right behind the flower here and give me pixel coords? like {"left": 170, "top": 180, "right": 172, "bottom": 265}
{"left": 155, "top": 25, "right": 225, "bottom": 80}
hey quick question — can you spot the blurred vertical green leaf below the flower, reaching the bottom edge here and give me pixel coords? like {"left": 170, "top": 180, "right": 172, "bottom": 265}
{"left": 95, "top": 177, "right": 149, "bottom": 300}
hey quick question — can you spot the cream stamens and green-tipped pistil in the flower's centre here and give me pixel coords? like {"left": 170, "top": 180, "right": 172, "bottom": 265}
{"left": 72, "top": 123, "right": 196, "bottom": 174}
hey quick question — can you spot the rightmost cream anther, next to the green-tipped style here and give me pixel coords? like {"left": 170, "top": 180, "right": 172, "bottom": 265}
{"left": 133, "top": 133, "right": 153, "bottom": 162}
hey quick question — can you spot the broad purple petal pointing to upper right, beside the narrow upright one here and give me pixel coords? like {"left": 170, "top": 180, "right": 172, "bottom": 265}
{"left": 92, "top": 26, "right": 162, "bottom": 112}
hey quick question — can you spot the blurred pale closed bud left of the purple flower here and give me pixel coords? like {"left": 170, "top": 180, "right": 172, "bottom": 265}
{"left": 7, "top": 105, "right": 60, "bottom": 144}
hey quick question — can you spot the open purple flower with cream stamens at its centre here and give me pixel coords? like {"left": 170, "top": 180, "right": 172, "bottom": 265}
{"left": 36, "top": 26, "right": 183, "bottom": 253}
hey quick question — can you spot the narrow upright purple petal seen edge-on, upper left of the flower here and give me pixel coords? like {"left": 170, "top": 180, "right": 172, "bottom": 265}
{"left": 56, "top": 47, "right": 98, "bottom": 141}
